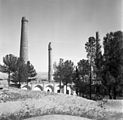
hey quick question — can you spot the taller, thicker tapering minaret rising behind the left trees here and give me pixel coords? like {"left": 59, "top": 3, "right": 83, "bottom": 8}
{"left": 20, "top": 17, "right": 28, "bottom": 63}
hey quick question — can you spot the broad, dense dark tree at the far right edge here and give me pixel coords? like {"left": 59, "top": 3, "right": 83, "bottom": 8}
{"left": 103, "top": 31, "right": 123, "bottom": 99}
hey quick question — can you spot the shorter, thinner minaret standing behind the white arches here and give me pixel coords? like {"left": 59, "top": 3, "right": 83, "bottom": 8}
{"left": 48, "top": 42, "right": 52, "bottom": 82}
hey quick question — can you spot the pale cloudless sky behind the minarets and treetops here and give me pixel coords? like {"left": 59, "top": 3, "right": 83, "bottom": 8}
{"left": 0, "top": 0, "right": 123, "bottom": 72}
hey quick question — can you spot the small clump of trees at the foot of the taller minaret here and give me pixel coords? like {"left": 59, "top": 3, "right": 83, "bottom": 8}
{"left": 0, "top": 54, "right": 37, "bottom": 87}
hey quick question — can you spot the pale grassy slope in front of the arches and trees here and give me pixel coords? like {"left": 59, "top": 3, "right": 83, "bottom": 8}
{"left": 0, "top": 88, "right": 123, "bottom": 120}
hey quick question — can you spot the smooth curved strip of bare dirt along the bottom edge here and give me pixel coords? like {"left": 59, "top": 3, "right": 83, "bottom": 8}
{"left": 25, "top": 115, "right": 91, "bottom": 120}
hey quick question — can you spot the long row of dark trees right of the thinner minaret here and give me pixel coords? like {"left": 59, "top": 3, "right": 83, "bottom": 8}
{"left": 54, "top": 31, "right": 123, "bottom": 99}
